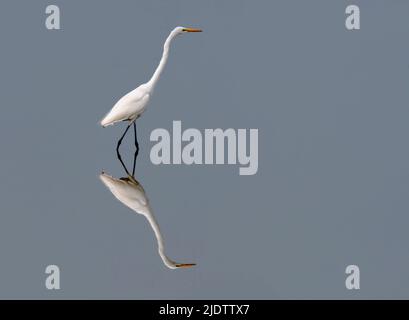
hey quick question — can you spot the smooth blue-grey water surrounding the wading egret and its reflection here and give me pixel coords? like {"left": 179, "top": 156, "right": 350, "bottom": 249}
{"left": 0, "top": 0, "right": 409, "bottom": 299}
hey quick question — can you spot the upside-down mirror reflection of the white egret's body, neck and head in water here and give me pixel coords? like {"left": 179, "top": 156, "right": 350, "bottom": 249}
{"left": 99, "top": 172, "right": 195, "bottom": 269}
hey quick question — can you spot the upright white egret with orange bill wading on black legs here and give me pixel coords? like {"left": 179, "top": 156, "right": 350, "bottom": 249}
{"left": 101, "top": 27, "right": 202, "bottom": 162}
